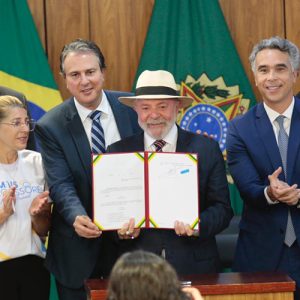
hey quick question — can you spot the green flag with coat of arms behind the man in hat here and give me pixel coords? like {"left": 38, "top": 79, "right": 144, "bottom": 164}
{"left": 136, "top": 0, "right": 255, "bottom": 214}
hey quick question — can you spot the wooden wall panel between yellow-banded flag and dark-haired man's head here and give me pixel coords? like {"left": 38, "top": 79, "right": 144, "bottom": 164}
{"left": 46, "top": 0, "right": 90, "bottom": 98}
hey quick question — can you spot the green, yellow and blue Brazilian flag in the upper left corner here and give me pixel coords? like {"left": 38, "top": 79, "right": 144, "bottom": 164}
{"left": 0, "top": 0, "right": 62, "bottom": 120}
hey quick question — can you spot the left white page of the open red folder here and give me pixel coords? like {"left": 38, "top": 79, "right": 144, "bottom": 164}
{"left": 93, "top": 153, "right": 145, "bottom": 230}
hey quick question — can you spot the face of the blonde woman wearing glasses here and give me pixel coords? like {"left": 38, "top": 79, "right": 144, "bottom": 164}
{"left": 0, "top": 107, "right": 29, "bottom": 153}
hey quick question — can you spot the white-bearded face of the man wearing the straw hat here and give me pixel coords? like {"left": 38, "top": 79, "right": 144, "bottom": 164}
{"left": 134, "top": 99, "right": 180, "bottom": 140}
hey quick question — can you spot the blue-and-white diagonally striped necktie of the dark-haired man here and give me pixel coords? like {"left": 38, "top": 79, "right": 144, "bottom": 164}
{"left": 89, "top": 110, "right": 105, "bottom": 154}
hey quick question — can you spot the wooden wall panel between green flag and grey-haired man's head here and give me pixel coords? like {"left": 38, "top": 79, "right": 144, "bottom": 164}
{"left": 219, "top": 0, "right": 284, "bottom": 100}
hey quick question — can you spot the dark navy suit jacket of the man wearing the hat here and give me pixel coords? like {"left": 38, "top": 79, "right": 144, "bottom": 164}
{"left": 108, "top": 127, "right": 232, "bottom": 274}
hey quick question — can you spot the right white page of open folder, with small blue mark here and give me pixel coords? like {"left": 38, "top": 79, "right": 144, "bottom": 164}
{"left": 148, "top": 153, "right": 199, "bottom": 229}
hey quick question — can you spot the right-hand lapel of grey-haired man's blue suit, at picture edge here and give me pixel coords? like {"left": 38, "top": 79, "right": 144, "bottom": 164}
{"left": 287, "top": 97, "right": 300, "bottom": 184}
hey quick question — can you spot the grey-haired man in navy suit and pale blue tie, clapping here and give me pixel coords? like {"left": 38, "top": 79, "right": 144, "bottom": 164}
{"left": 227, "top": 37, "right": 300, "bottom": 299}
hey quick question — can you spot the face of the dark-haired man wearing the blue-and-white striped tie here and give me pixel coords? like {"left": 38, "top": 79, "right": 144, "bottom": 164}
{"left": 64, "top": 52, "right": 104, "bottom": 110}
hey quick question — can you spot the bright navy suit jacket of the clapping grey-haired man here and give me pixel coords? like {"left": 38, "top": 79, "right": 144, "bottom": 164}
{"left": 227, "top": 98, "right": 300, "bottom": 271}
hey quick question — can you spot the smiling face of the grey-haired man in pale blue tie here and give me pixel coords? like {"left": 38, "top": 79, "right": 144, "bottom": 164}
{"left": 254, "top": 49, "right": 297, "bottom": 113}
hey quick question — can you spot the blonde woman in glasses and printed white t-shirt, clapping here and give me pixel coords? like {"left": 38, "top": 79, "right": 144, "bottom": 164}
{"left": 0, "top": 96, "right": 50, "bottom": 300}
